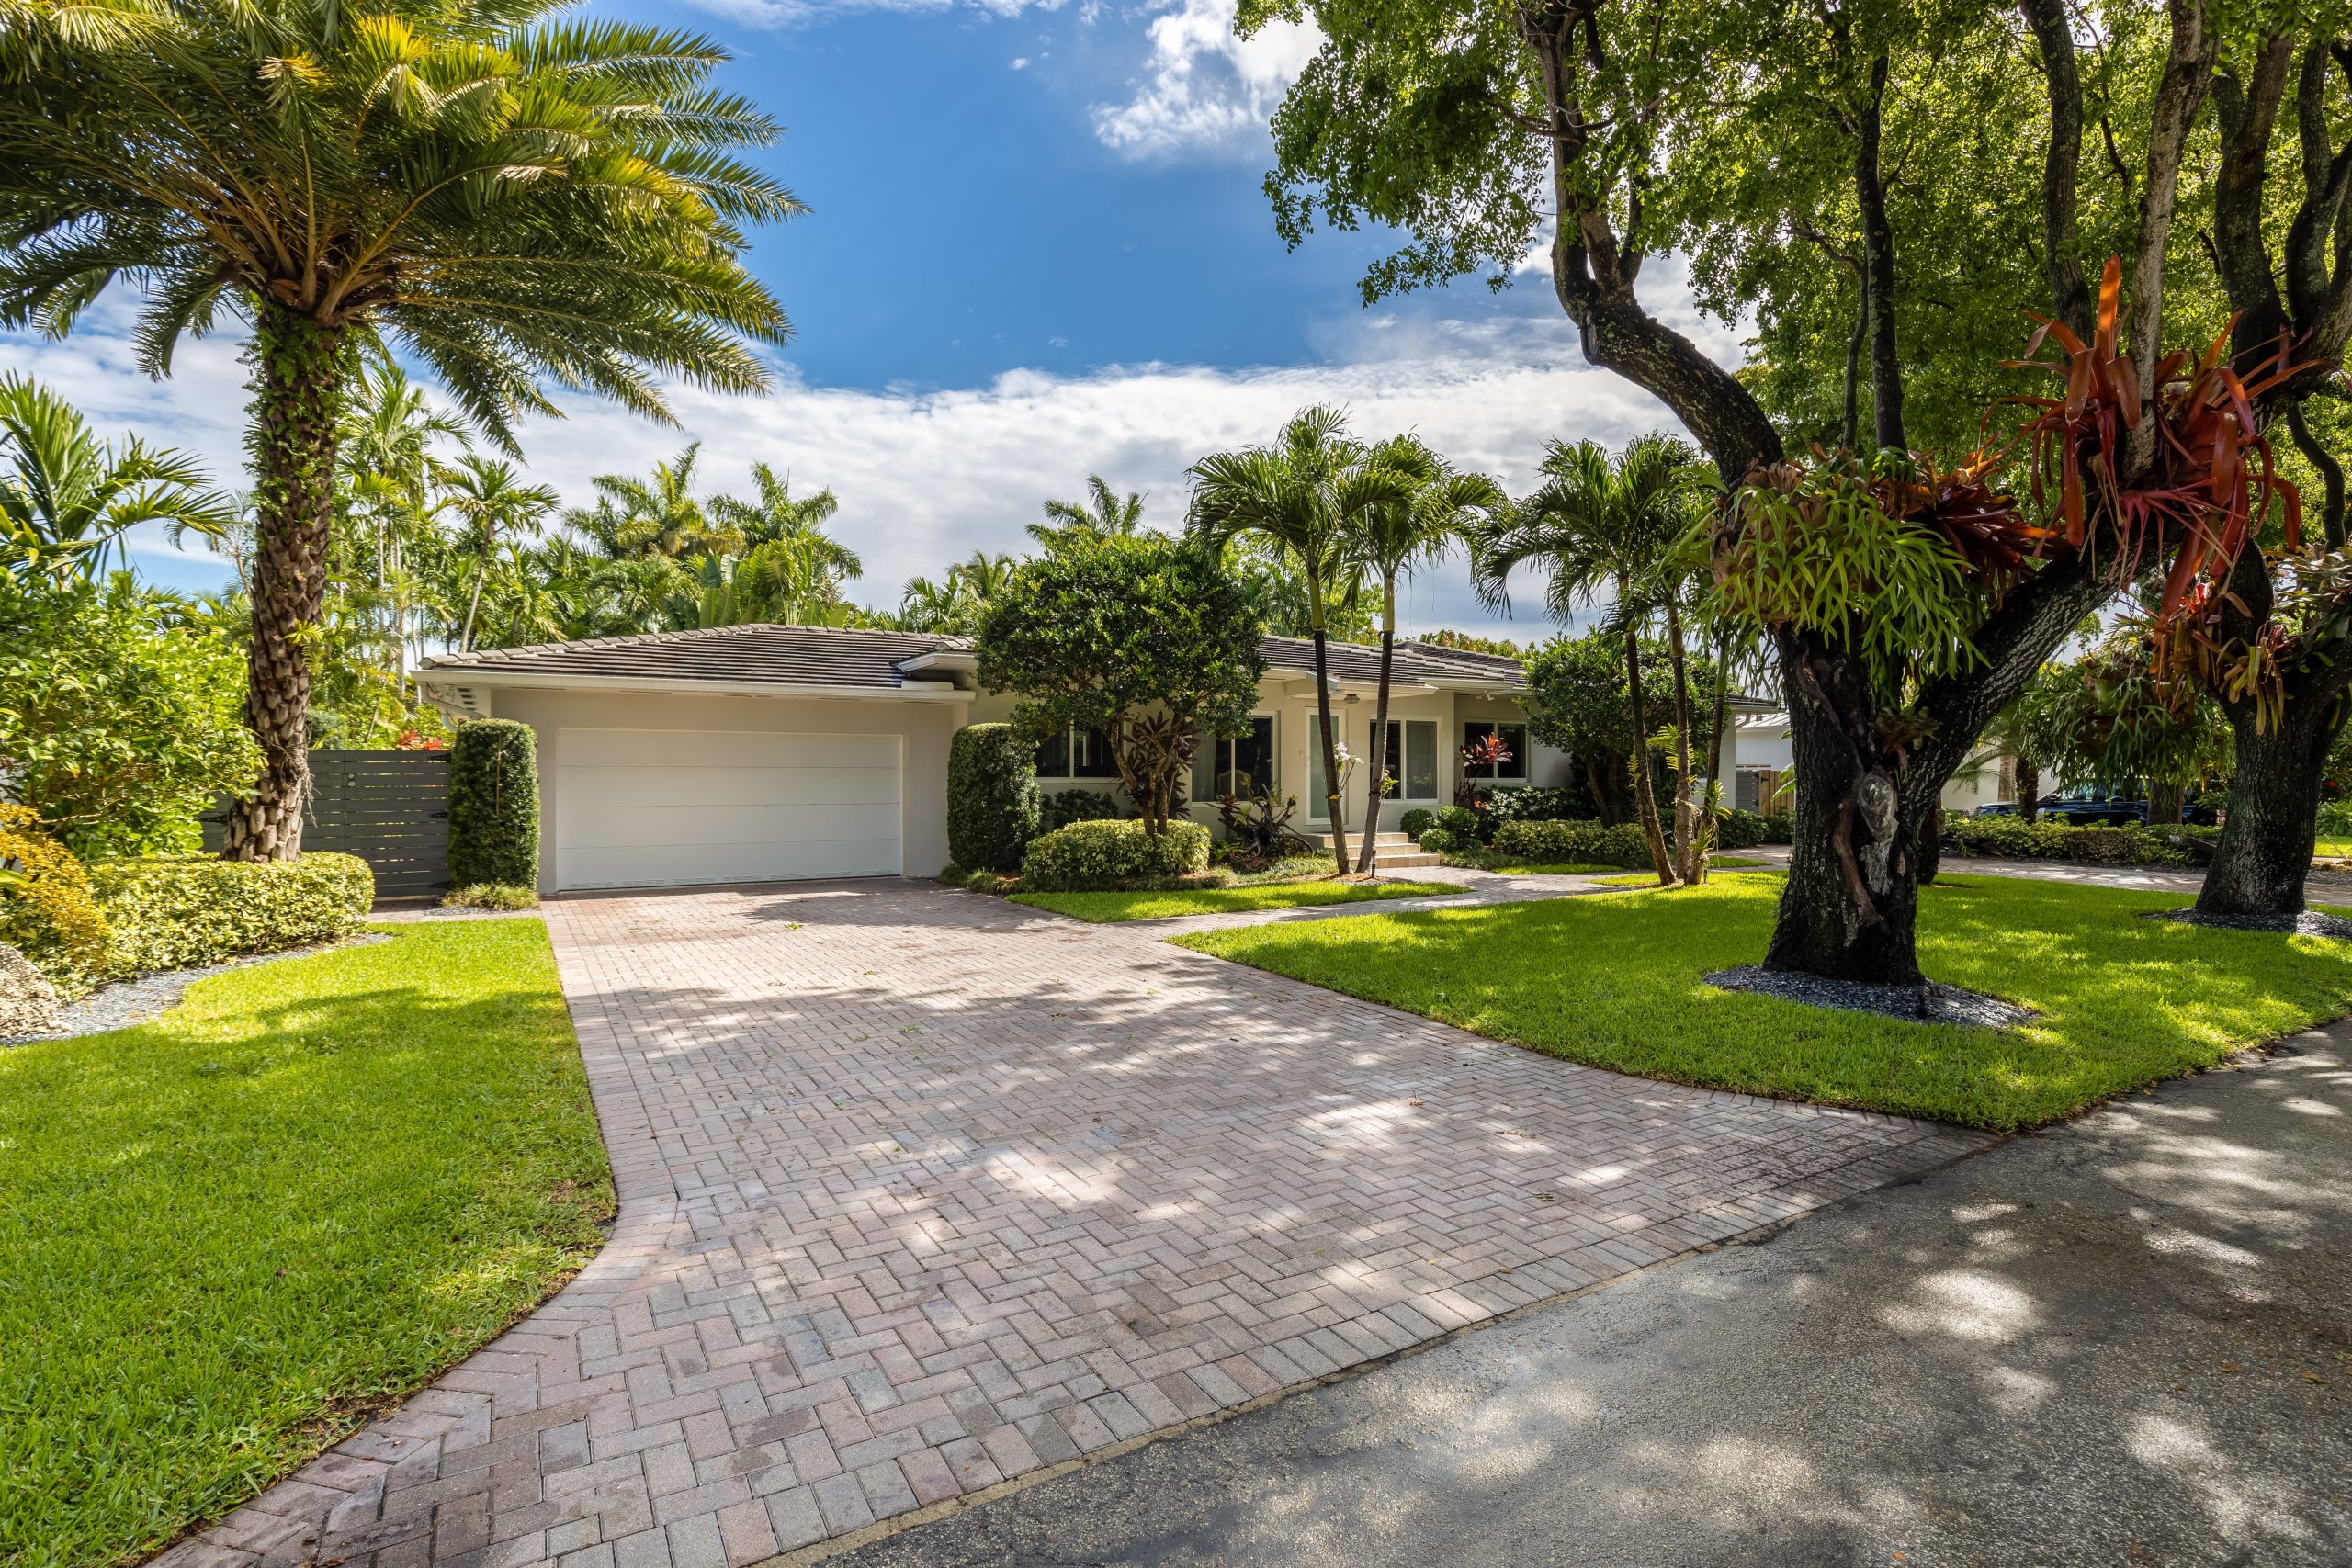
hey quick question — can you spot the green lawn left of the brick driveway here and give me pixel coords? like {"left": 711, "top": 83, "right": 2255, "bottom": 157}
{"left": 0, "top": 919, "right": 614, "bottom": 1568}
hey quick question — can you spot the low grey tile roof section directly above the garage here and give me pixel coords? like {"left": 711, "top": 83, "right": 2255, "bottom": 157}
{"left": 419, "top": 623, "right": 971, "bottom": 691}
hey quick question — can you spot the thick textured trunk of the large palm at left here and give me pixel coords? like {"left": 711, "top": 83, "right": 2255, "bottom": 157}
{"left": 221, "top": 303, "right": 344, "bottom": 861}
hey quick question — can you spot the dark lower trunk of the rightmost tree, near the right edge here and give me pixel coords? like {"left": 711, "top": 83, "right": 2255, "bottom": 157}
{"left": 2197, "top": 698, "right": 2340, "bottom": 915}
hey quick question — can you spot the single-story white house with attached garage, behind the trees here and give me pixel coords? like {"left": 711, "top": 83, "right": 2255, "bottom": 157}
{"left": 416, "top": 626, "right": 1757, "bottom": 894}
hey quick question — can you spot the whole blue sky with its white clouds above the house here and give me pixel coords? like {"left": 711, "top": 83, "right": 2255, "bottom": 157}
{"left": 0, "top": 0, "right": 1738, "bottom": 635}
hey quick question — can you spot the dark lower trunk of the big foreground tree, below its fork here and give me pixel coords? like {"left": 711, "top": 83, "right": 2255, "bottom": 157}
{"left": 1764, "top": 632, "right": 1931, "bottom": 985}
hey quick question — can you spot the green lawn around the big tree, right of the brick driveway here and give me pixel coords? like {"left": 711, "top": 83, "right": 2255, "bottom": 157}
{"left": 1171, "top": 877, "right": 2352, "bottom": 1131}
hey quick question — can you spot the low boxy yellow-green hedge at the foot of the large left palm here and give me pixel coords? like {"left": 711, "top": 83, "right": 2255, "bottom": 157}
{"left": 89, "top": 851, "right": 377, "bottom": 974}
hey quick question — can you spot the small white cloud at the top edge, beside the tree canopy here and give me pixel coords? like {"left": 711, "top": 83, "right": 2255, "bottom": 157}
{"left": 1093, "top": 0, "right": 1322, "bottom": 157}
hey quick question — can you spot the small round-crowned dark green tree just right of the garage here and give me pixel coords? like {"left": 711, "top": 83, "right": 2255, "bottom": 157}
{"left": 978, "top": 531, "right": 1265, "bottom": 832}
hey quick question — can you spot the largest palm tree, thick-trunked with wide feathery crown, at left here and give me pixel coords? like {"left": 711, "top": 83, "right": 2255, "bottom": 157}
{"left": 0, "top": 0, "right": 797, "bottom": 861}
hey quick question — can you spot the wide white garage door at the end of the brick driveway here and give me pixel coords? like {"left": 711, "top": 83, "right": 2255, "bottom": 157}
{"left": 555, "top": 728, "right": 903, "bottom": 888}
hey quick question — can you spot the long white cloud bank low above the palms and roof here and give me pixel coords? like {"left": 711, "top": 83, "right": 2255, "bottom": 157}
{"left": 0, "top": 293, "right": 1712, "bottom": 635}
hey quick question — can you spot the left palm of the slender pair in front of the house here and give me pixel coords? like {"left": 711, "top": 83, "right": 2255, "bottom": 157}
{"left": 1188, "top": 407, "right": 1404, "bottom": 877}
